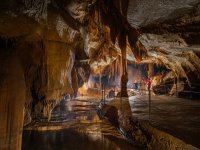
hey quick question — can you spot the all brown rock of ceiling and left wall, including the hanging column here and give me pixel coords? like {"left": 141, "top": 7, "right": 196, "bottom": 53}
{"left": 0, "top": 0, "right": 200, "bottom": 149}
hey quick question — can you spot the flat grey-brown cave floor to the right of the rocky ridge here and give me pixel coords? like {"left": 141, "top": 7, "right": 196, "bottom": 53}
{"left": 129, "top": 95, "right": 200, "bottom": 148}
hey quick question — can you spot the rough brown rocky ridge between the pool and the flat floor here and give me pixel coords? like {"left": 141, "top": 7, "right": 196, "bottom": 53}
{"left": 99, "top": 99, "right": 198, "bottom": 150}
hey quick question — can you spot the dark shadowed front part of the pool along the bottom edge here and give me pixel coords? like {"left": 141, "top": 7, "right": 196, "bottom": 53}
{"left": 23, "top": 129, "right": 138, "bottom": 150}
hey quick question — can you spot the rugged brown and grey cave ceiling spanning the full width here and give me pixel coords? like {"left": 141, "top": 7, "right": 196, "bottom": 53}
{"left": 0, "top": 0, "right": 200, "bottom": 82}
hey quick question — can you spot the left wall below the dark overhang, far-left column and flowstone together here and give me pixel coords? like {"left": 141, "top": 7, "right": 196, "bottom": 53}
{"left": 0, "top": 33, "right": 77, "bottom": 149}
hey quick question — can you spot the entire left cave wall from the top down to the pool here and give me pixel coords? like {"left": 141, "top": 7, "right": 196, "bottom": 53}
{"left": 0, "top": 1, "right": 91, "bottom": 149}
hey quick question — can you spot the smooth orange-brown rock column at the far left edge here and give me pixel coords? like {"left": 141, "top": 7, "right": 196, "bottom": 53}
{"left": 0, "top": 50, "right": 25, "bottom": 150}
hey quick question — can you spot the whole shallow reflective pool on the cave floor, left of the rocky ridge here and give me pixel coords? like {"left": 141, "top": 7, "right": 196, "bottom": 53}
{"left": 22, "top": 98, "right": 140, "bottom": 150}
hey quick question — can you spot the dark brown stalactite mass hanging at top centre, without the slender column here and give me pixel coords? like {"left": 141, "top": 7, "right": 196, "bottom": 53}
{"left": 99, "top": 0, "right": 146, "bottom": 61}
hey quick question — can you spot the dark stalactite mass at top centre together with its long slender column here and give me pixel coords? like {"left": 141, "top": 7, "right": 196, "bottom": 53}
{"left": 94, "top": 0, "right": 146, "bottom": 96}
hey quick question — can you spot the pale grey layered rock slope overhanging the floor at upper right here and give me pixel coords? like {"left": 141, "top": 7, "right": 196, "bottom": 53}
{"left": 127, "top": 0, "right": 200, "bottom": 92}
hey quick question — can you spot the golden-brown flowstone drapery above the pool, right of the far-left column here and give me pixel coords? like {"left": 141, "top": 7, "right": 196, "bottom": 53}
{"left": 23, "top": 41, "right": 74, "bottom": 120}
